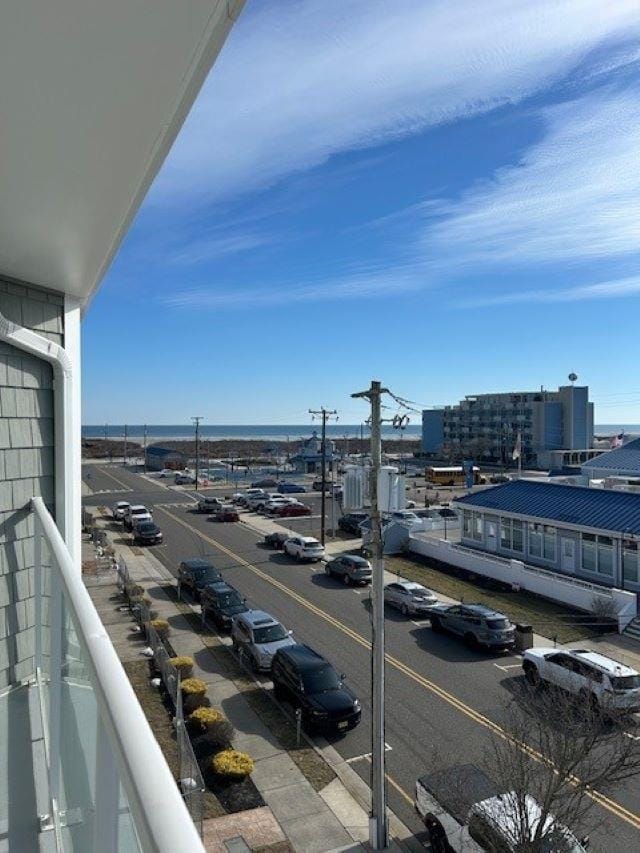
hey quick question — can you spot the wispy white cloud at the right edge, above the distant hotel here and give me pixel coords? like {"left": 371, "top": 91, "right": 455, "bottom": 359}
{"left": 423, "top": 89, "right": 640, "bottom": 268}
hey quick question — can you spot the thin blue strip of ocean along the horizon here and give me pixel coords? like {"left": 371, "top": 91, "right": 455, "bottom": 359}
{"left": 82, "top": 423, "right": 640, "bottom": 441}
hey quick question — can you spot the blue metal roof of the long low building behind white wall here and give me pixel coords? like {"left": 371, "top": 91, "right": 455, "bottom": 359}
{"left": 454, "top": 480, "right": 640, "bottom": 534}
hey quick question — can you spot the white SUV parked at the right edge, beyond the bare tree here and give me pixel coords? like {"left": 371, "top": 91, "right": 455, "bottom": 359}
{"left": 522, "top": 648, "right": 640, "bottom": 714}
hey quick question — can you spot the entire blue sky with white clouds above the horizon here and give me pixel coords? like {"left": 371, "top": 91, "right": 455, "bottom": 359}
{"left": 83, "top": 0, "right": 640, "bottom": 424}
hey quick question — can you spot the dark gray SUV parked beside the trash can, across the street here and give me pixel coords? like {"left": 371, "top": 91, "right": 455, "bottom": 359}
{"left": 429, "top": 604, "right": 515, "bottom": 651}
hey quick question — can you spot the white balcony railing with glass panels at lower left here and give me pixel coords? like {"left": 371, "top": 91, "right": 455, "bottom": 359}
{"left": 31, "top": 498, "right": 203, "bottom": 853}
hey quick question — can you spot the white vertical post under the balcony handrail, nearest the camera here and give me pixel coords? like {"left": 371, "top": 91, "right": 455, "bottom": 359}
{"left": 92, "top": 716, "right": 120, "bottom": 853}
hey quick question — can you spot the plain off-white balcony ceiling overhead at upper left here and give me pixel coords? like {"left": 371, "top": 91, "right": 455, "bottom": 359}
{"left": 0, "top": 0, "right": 244, "bottom": 302}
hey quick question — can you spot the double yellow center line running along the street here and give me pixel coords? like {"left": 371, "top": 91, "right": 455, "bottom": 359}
{"left": 157, "top": 507, "right": 640, "bottom": 829}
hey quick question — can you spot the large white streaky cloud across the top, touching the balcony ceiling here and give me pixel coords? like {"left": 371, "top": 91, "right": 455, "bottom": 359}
{"left": 152, "top": 0, "right": 640, "bottom": 204}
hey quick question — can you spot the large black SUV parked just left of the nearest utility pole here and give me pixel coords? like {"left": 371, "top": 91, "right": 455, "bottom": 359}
{"left": 271, "top": 644, "right": 362, "bottom": 732}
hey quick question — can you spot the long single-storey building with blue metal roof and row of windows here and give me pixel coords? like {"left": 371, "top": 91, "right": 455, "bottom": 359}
{"left": 454, "top": 480, "right": 640, "bottom": 592}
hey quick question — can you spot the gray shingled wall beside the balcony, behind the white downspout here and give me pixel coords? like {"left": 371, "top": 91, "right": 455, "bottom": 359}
{"left": 0, "top": 277, "right": 64, "bottom": 689}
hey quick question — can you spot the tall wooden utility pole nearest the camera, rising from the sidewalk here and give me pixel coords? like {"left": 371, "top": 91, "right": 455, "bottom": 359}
{"left": 351, "top": 381, "right": 389, "bottom": 850}
